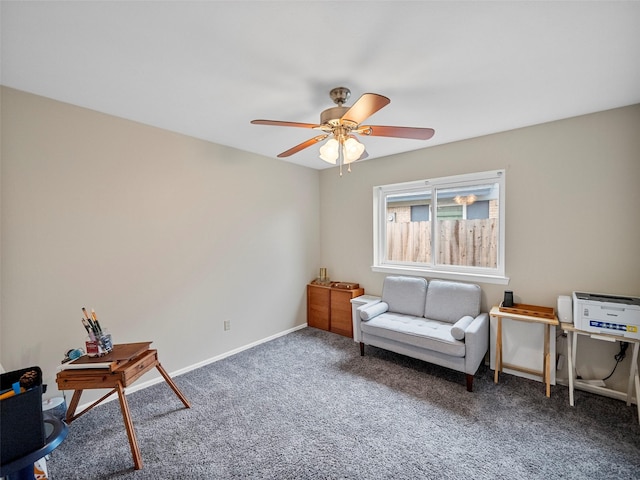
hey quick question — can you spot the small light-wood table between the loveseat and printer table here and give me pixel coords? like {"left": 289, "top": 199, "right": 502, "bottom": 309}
{"left": 489, "top": 305, "right": 560, "bottom": 397}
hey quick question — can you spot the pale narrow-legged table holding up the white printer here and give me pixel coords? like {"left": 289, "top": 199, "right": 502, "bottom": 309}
{"left": 560, "top": 323, "right": 640, "bottom": 422}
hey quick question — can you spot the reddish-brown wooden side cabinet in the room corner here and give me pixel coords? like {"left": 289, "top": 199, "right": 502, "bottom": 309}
{"left": 307, "top": 284, "right": 364, "bottom": 338}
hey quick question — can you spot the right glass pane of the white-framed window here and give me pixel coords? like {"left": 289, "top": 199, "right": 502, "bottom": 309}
{"left": 436, "top": 183, "right": 500, "bottom": 268}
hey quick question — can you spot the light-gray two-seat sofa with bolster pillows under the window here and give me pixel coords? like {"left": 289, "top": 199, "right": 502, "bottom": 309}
{"left": 354, "top": 276, "right": 489, "bottom": 392}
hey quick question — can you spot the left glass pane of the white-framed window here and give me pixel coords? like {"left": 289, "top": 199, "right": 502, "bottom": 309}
{"left": 385, "top": 191, "right": 431, "bottom": 263}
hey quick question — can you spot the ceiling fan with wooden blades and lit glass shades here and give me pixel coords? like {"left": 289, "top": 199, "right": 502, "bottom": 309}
{"left": 251, "top": 87, "right": 435, "bottom": 175}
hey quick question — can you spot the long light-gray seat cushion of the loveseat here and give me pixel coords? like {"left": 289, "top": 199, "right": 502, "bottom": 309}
{"left": 361, "top": 311, "right": 466, "bottom": 357}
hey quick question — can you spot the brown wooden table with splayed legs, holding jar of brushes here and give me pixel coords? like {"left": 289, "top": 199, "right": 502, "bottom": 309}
{"left": 56, "top": 342, "right": 191, "bottom": 470}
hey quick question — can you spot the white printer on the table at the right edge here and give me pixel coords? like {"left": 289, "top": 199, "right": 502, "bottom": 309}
{"left": 573, "top": 292, "right": 640, "bottom": 339}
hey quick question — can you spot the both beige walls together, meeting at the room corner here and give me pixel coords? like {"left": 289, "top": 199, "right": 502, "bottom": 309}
{"left": 0, "top": 88, "right": 640, "bottom": 399}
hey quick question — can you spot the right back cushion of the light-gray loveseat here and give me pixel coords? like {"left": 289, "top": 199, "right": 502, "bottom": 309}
{"left": 424, "top": 280, "right": 481, "bottom": 323}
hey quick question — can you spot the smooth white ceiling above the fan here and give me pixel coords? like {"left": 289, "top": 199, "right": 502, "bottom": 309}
{"left": 0, "top": 0, "right": 640, "bottom": 169}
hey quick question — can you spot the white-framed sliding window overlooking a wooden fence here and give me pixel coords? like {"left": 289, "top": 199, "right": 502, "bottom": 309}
{"left": 373, "top": 170, "right": 508, "bottom": 284}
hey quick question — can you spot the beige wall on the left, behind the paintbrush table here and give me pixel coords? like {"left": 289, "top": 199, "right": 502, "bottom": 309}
{"left": 0, "top": 88, "right": 320, "bottom": 400}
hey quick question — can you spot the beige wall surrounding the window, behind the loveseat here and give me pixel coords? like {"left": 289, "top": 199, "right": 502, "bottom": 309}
{"left": 320, "top": 105, "right": 640, "bottom": 308}
